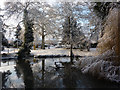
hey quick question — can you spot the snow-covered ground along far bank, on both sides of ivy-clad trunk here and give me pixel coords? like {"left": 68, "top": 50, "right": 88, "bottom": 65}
{"left": 1, "top": 48, "right": 97, "bottom": 56}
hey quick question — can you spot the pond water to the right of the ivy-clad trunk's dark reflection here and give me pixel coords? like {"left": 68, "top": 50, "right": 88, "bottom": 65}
{"left": 33, "top": 58, "right": 118, "bottom": 88}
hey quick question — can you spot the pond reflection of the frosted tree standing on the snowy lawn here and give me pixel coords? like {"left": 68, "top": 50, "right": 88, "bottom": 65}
{"left": 33, "top": 58, "right": 60, "bottom": 88}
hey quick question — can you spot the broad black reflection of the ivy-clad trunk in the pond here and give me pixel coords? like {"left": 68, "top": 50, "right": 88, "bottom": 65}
{"left": 16, "top": 60, "right": 34, "bottom": 88}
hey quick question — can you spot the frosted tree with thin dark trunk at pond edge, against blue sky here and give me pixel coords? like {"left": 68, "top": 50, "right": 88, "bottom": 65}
{"left": 53, "top": 2, "right": 89, "bottom": 60}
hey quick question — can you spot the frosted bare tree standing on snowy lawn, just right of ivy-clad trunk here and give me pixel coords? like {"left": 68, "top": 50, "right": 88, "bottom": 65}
{"left": 31, "top": 2, "right": 59, "bottom": 49}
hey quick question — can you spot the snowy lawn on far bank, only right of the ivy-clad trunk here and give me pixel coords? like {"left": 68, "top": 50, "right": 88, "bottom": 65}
{"left": 31, "top": 48, "right": 97, "bottom": 56}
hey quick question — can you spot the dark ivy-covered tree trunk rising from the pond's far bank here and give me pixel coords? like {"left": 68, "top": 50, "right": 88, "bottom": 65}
{"left": 18, "top": 8, "right": 34, "bottom": 58}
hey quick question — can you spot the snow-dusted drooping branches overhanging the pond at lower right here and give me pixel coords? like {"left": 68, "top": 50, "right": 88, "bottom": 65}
{"left": 76, "top": 51, "right": 120, "bottom": 83}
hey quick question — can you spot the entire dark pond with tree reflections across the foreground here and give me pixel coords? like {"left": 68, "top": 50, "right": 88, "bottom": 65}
{"left": 0, "top": 58, "right": 119, "bottom": 88}
